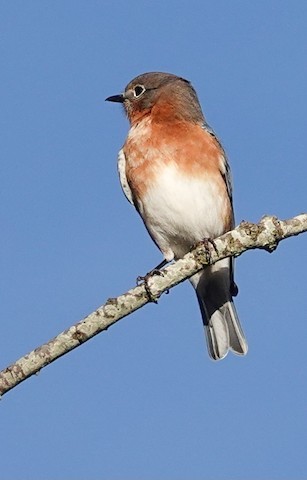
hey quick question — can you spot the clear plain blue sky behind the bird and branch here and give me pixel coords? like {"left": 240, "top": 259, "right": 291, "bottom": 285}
{"left": 0, "top": 0, "right": 307, "bottom": 480}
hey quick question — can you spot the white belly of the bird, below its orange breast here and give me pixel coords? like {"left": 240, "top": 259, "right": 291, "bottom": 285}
{"left": 139, "top": 164, "right": 227, "bottom": 260}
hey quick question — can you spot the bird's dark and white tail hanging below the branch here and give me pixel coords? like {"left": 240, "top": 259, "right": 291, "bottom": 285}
{"left": 191, "top": 259, "right": 248, "bottom": 360}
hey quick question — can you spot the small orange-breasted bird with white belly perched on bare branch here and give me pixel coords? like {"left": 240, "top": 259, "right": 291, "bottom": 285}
{"left": 106, "top": 72, "right": 248, "bottom": 360}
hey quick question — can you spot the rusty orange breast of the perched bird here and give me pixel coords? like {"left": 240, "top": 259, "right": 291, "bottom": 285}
{"left": 124, "top": 113, "right": 232, "bottom": 230}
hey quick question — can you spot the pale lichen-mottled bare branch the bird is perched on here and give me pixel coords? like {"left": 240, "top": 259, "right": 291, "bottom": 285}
{"left": 0, "top": 214, "right": 307, "bottom": 395}
